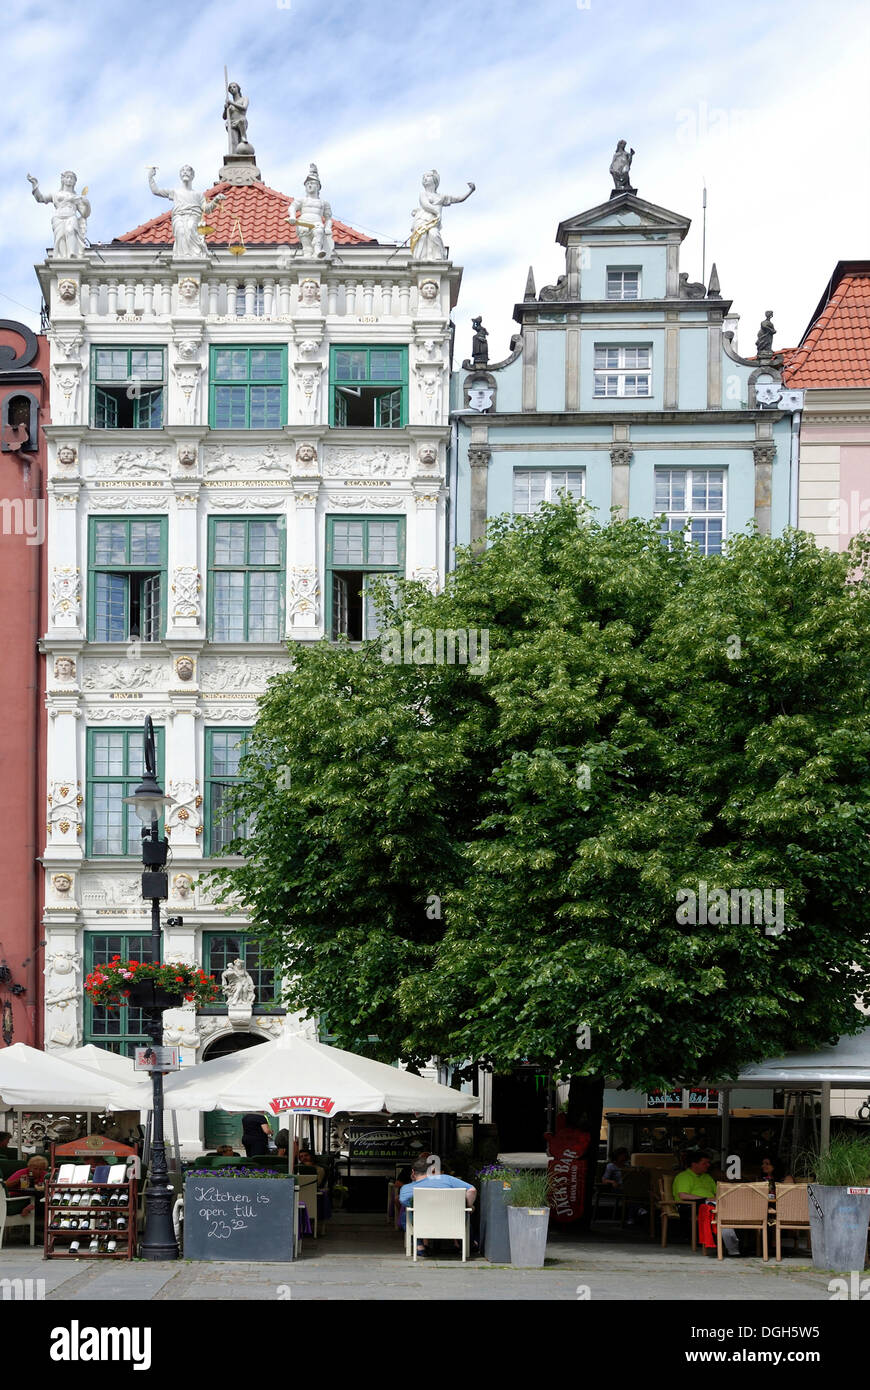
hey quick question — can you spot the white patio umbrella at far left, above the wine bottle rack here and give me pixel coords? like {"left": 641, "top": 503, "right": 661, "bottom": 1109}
{"left": 0, "top": 1043, "right": 150, "bottom": 1111}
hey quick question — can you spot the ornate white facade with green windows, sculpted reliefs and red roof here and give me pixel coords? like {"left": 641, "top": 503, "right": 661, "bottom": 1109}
{"left": 38, "top": 135, "right": 460, "bottom": 1147}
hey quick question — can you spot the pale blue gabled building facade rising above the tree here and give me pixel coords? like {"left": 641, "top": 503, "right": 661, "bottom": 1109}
{"left": 450, "top": 176, "right": 798, "bottom": 564}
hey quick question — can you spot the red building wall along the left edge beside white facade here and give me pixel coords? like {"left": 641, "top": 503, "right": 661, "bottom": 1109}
{"left": 0, "top": 320, "right": 49, "bottom": 1047}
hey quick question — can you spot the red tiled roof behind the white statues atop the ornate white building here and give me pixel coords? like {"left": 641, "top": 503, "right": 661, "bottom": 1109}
{"left": 115, "top": 183, "right": 378, "bottom": 246}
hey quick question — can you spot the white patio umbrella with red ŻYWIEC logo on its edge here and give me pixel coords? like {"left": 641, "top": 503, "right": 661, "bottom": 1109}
{"left": 159, "top": 1033, "right": 478, "bottom": 1118}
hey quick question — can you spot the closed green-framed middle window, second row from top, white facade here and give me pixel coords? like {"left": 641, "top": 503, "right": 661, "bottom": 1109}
{"left": 207, "top": 516, "right": 286, "bottom": 642}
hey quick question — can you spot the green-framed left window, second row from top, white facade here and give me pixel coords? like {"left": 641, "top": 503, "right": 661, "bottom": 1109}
{"left": 88, "top": 516, "right": 167, "bottom": 642}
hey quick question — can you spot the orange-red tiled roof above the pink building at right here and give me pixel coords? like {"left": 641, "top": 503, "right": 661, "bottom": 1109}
{"left": 784, "top": 261, "right": 870, "bottom": 388}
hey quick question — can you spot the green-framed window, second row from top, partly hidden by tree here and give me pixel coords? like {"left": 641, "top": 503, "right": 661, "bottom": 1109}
{"left": 327, "top": 516, "right": 404, "bottom": 641}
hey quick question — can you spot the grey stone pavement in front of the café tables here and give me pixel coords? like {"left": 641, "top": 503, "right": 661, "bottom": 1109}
{"left": 0, "top": 1226, "right": 831, "bottom": 1304}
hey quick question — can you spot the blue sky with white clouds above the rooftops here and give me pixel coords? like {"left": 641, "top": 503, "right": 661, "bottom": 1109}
{"left": 0, "top": 0, "right": 870, "bottom": 361}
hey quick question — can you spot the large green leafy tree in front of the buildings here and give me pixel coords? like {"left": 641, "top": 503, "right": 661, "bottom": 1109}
{"left": 209, "top": 500, "right": 870, "bottom": 1084}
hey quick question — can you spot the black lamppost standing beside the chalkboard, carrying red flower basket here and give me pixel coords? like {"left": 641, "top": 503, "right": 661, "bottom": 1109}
{"left": 124, "top": 714, "right": 178, "bottom": 1259}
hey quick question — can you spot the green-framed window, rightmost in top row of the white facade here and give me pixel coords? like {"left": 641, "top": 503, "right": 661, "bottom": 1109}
{"left": 329, "top": 343, "right": 409, "bottom": 430}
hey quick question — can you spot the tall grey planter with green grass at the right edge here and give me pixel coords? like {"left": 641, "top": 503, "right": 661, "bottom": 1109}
{"left": 805, "top": 1134, "right": 870, "bottom": 1270}
